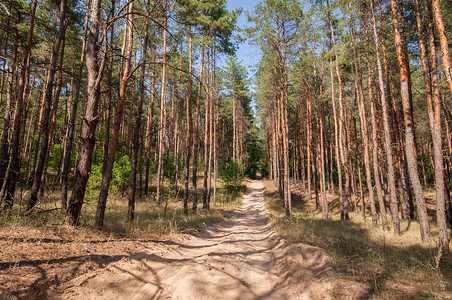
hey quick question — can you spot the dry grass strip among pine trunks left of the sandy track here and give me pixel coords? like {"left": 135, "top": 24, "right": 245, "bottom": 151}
{"left": 0, "top": 179, "right": 243, "bottom": 239}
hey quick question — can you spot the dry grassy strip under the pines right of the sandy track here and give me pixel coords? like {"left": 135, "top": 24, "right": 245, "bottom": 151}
{"left": 264, "top": 180, "right": 452, "bottom": 299}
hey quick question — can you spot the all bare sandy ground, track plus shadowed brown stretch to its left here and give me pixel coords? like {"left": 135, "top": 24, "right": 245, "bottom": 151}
{"left": 0, "top": 181, "right": 371, "bottom": 299}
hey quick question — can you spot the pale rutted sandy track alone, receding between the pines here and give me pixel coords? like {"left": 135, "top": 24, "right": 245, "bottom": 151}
{"left": 50, "top": 181, "right": 365, "bottom": 299}
